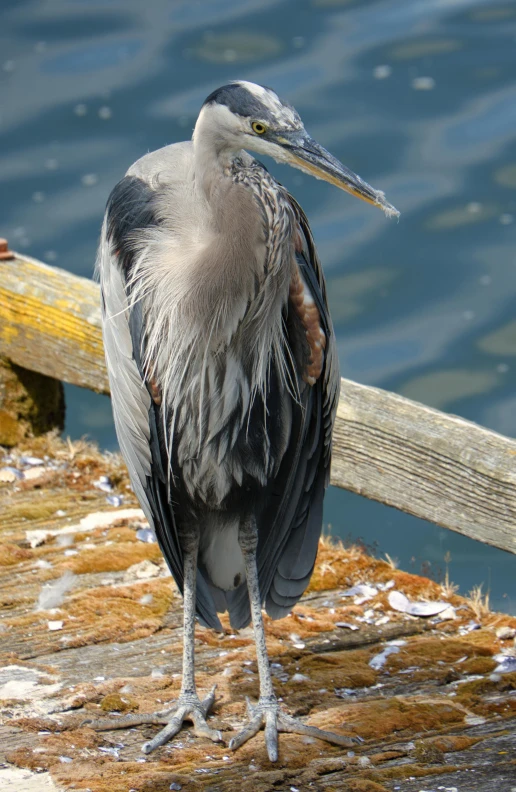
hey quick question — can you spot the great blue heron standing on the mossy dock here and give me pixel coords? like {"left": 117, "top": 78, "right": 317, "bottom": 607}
{"left": 93, "top": 81, "right": 398, "bottom": 761}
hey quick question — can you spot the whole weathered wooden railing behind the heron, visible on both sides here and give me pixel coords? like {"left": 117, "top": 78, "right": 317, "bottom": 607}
{"left": 0, "top": 254, "right": 516, "bottom": 553}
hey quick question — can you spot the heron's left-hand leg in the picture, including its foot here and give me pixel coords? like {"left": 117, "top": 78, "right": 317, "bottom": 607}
{"left": 83, "top": 529, "right": 223, "bottom": 754}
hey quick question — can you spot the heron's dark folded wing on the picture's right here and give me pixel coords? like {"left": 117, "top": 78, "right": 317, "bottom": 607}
{"left": 226, "top": 190, "right": 340, "bottom": 627}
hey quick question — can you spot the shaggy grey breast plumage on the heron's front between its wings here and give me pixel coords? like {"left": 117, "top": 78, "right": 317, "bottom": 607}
{"left": 125, "top": 148, "right": 298, "bottom": 508}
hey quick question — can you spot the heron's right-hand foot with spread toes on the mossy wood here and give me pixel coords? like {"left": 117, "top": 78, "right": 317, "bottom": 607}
{"left": 229, "top": 696, "right": 362, "bottom": 762}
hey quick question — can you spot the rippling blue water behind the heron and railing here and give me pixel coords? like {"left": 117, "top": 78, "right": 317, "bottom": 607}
{"left": 0, "top": 0, "right": 516, "bottom": 612}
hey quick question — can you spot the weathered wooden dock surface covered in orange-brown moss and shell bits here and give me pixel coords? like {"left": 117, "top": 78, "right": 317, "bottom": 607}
{"left": 0, "top": 438, "right": 516, "bottom": 792}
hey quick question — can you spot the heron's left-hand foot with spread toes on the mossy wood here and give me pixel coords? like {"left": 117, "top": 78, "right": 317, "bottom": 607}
{"left": 85, "top": 685, "right": 224, "bottom": 754}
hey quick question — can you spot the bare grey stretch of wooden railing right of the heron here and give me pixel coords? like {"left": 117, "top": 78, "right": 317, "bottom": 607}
{"left": 331, "top": 379, "right": 516, "bottom": 553}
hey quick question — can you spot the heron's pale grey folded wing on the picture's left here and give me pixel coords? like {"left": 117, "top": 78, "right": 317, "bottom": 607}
{"left": 97, "top": 176, "right": 221, "bottom": 630}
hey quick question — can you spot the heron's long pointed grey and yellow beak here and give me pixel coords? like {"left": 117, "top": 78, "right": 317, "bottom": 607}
{"left": 277, "top": 134, "right": 400, "bottom": 217}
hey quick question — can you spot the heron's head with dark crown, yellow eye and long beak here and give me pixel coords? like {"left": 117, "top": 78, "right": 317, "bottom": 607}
{"left": 194, "top": 80, "right": 399, "bottom": 217}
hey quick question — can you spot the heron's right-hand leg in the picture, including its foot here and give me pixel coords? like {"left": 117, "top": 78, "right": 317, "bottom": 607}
{"left": 229, "top": 520, "right": 360, "bottom": 762}
